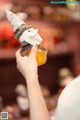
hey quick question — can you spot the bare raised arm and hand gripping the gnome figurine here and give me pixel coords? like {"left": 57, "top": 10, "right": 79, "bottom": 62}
{"left": 16, "top": 46, "right": 50, "bottom": 120}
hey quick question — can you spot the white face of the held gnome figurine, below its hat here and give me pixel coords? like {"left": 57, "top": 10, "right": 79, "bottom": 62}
{"left": 20, "top": 28, "right": 42, "bottom": 45}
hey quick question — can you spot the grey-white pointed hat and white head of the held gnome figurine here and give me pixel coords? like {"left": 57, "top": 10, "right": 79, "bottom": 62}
{"left": 6, "top": 10, "right": 42, "bottom": 46}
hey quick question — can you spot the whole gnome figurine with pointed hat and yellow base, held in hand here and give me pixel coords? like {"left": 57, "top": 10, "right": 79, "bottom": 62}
{"left": 6, "top": 10, "right": 47, "bottom": 65}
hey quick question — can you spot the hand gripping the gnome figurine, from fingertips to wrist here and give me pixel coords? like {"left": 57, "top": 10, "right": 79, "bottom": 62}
{"left": 16, "top": 45, "right": 38, "bottom": 79}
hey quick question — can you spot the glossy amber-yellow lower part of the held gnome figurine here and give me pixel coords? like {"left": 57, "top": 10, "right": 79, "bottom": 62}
{"left": 26, "top": 49, "right": 47, "bottom": 66}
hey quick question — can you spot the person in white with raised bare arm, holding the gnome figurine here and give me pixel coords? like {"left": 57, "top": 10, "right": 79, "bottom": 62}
{"left": 16, "top": 46, "right": 80, "bottom": 120}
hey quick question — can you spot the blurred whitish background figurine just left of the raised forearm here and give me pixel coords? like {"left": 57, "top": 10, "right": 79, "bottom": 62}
{"left": 15, "top": 84, "right": 29, "bottom": 115}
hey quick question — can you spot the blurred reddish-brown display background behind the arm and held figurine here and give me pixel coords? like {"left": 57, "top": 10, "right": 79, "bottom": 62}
{"left": 0, "top": 0, "right": 80, "bottom": 120}
